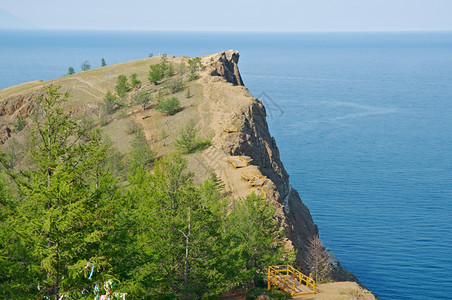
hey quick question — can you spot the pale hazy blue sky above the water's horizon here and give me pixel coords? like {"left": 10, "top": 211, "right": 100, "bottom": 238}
{"left": 0, "top": 0, "right": 452, "bottom": 31}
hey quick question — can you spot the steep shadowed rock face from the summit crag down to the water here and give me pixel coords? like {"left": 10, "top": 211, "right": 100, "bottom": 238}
{"left": 207, "top": 51, "right": 357, "bottom": 281}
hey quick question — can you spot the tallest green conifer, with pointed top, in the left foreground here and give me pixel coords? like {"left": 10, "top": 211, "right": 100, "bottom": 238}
{"left": 2, "top": 87, "right": 122, "bottom": 299}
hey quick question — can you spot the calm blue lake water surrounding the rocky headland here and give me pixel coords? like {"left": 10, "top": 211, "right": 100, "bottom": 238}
{"left": 0, "top": 31, "right": 452, "bottom": 299}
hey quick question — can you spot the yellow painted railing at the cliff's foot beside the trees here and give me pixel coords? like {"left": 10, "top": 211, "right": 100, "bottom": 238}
{"left": 267, "top": 265, "right": 315, "bottom": 297}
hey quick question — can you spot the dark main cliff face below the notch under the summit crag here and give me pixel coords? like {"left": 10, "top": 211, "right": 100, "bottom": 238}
{"left": 228, "top": 101, "right": 318, "bottom": 262}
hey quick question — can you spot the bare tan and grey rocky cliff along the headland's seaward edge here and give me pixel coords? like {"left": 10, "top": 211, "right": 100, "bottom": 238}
{"left": 196, "top": 50, "right": 357, "bottom": 281}
